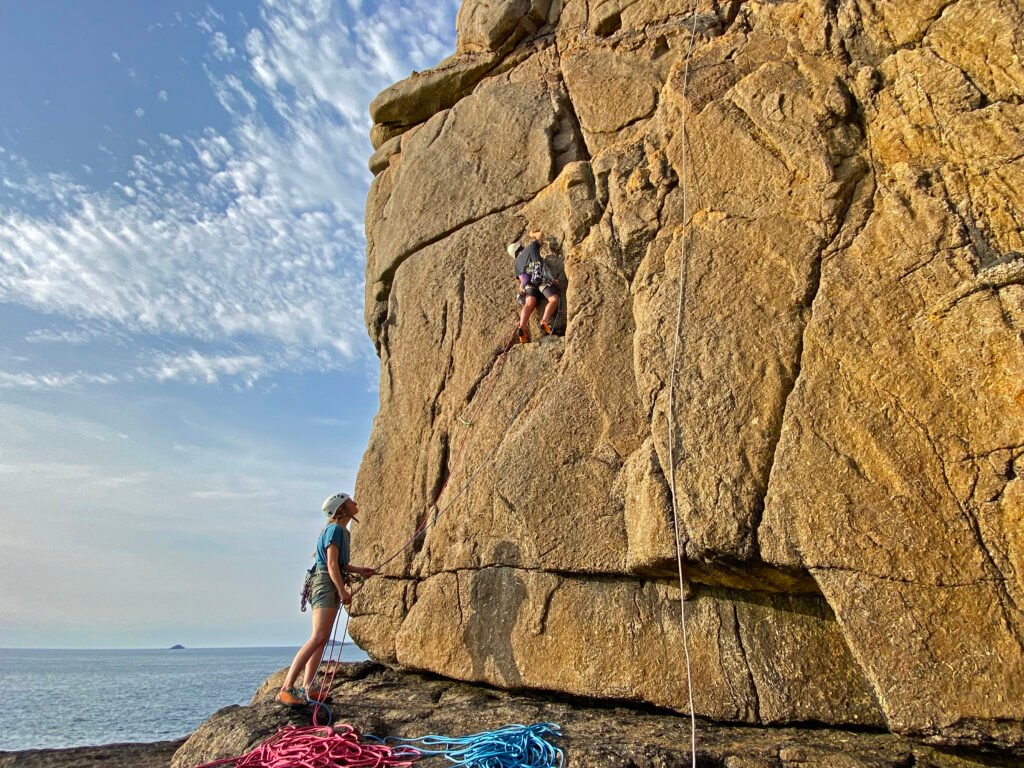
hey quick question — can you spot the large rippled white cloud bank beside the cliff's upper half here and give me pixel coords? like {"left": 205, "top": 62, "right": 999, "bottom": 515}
{"left": 0, "top": 0, "right": 458, "bottom": 387}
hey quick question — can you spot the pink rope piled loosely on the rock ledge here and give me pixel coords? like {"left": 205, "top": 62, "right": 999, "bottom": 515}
{"left": 196, "top": 725, "right": 421, "bottom": 768}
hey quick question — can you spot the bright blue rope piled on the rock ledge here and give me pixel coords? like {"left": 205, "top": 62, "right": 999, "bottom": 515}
{"left": 369, "top": 723, "right": 564, "bottom": 768}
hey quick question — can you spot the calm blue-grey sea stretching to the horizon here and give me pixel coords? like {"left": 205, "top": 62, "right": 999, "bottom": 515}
{"left": 0, "top": 643, "right": 367, "bottom": 751}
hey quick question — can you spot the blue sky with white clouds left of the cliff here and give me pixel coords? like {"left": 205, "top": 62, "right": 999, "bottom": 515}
{"left": 0, "top": 0, "right": 459, "bottom": 647}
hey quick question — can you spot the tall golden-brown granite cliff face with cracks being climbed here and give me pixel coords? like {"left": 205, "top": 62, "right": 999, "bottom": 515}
{"left": 351, "top": 0, "right": 1024, "bottom": 746}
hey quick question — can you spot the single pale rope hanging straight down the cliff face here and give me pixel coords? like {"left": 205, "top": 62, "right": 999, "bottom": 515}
{"left": 668, "top": 3, "right": 697, "bottom": 768}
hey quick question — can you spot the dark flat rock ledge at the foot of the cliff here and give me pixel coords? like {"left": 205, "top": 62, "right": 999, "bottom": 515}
{"left": 171, "top": 662, "right": 1020, "bottom": 768}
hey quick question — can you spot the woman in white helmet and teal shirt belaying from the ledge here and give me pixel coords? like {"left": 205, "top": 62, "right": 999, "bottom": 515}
{"left": 278, "top": 494, "right": 376, "bottom": 706}
